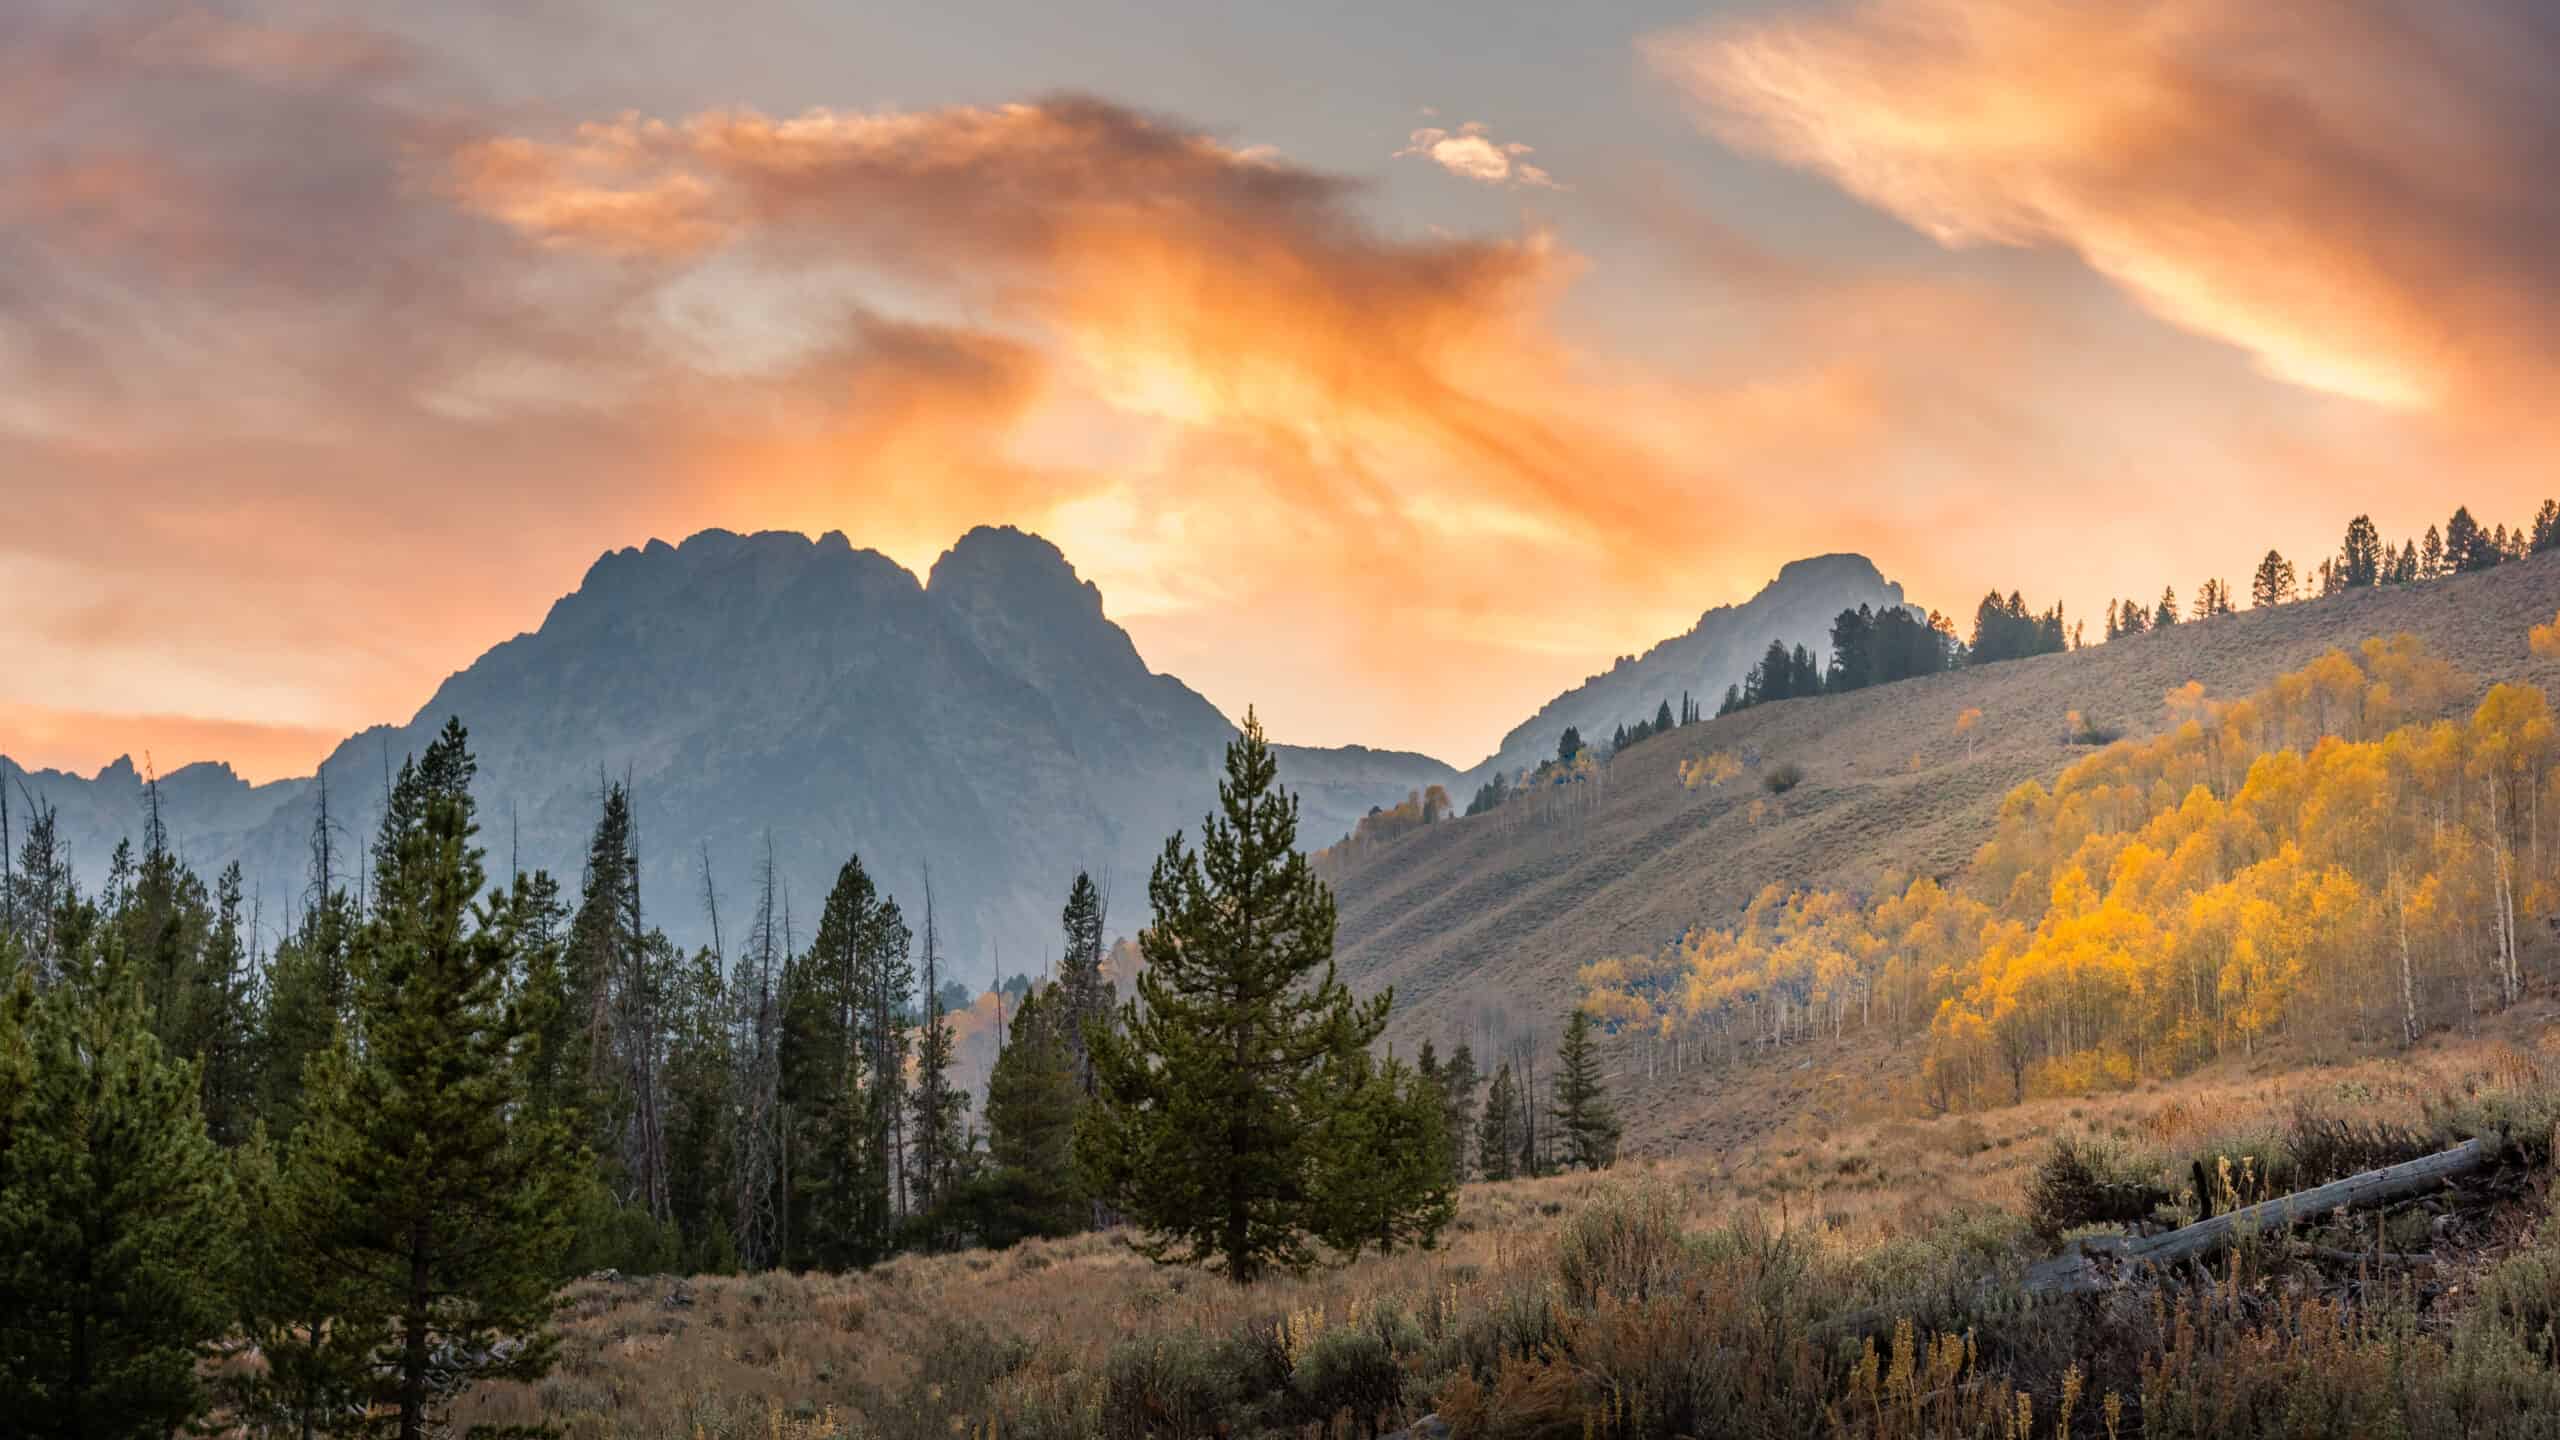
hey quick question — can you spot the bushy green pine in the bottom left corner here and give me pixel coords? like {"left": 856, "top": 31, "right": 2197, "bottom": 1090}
{"left": 0, "top": 958, "right": 241, "bottom": 1440}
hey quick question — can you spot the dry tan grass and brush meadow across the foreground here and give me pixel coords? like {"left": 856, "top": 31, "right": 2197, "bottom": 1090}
{"left": 440, "top": 1019, "right": 2560, "bottom": 1440}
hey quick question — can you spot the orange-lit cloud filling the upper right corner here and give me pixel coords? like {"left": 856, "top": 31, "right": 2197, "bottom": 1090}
{"left": 1646, "top": 0, "right": 2560, "bottom": 410}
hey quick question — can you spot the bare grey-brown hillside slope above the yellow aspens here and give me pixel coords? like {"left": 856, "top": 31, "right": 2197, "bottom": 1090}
{"left": 1336, "top": 556, "right": 2560, "bottom": 1140}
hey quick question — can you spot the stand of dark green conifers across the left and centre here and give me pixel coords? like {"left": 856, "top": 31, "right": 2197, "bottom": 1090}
{"left": 0, "top": 720, "right": 1605, "bottom": 1440}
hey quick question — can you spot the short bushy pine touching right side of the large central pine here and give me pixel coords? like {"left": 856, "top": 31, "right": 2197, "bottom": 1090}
{"left": 1316, "top": 1051, "right": 1457, "bottom": 1258}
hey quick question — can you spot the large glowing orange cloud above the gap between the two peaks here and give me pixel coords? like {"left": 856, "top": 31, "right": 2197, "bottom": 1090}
{"left": 448, "top": 97, "right": 1751, "bottom": 737}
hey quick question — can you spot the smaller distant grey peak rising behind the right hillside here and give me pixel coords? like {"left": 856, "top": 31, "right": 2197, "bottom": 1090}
{"left": 1459, "top": 556, "right": 1902, "bottom": 778}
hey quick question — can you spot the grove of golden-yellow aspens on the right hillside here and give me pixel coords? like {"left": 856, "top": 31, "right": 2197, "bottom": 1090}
{"left": 1582, "top": 625, "right": 2560, "bottom": 1107}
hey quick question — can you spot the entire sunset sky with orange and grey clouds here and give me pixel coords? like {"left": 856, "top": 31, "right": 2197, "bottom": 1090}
{"left": 0, "top": 0, "right": 2560, "bottom": 779}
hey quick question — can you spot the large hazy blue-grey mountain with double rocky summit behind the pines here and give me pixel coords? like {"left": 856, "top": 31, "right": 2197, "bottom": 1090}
{"left": 0, "top": 528, "right": 1457, "bottom": 979}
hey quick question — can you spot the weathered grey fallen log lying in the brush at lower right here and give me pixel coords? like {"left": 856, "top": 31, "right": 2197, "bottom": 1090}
{"left": 1820, "top": 1138, "right": 2499, "bottom": 1338}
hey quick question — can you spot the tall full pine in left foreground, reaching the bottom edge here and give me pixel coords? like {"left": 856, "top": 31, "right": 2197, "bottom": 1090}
{"left": 282, "top": 720, "right": 576, "bottom": 1440}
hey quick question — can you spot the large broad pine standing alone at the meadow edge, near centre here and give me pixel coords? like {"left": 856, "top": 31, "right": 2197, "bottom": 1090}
{"left": 1075, "top": 712, "right": 1393, "bottom": 1284}
